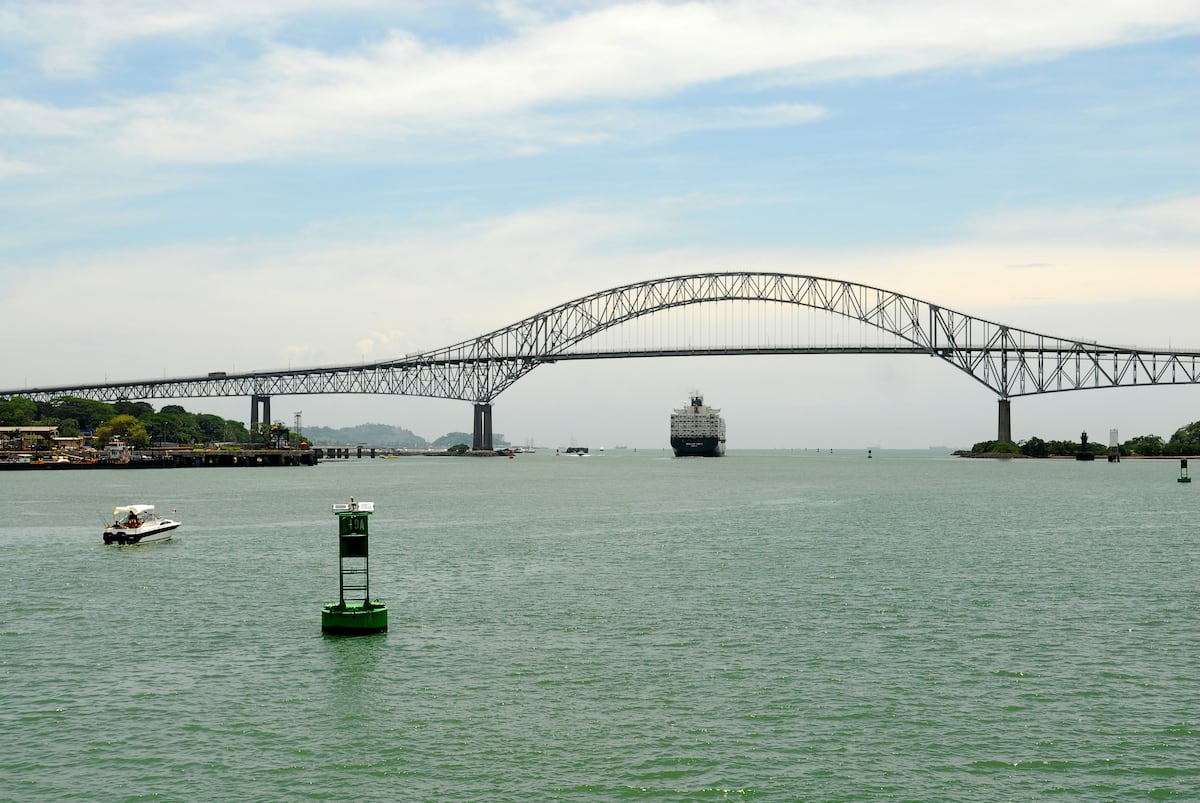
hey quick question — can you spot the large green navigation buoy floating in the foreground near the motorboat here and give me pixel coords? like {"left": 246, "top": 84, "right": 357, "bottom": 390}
{"left": 320, "top": 497, "right": 388, "bottom": 636}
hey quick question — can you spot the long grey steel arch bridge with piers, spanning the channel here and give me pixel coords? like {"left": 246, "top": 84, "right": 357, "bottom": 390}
{"left": 0, "top": 271, "right": 1200, "bottom": 449}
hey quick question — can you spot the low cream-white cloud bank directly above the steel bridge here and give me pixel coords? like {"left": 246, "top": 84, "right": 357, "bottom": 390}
{"left": 0, "top": 194, "right": 1200, "bottom": 383}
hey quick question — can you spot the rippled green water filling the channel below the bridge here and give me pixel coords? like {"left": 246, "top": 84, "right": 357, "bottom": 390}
{"left": 0, "top": 450, "right": 1200, "bottom": 802}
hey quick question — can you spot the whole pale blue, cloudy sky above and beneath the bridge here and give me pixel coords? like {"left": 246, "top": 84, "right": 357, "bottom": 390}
{"left": 0, "top": 0, "right": 1200, "bottom": 449}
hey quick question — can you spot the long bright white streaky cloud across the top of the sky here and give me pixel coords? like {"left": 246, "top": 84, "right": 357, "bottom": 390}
{"left": 10, "top": 0, "right": 1200, "bottom": 163}
